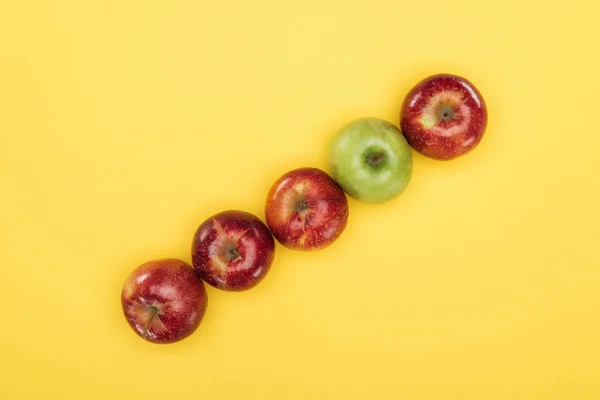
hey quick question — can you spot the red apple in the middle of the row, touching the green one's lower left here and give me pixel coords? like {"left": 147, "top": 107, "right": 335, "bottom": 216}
{"left": 265, "top": 167, "right": 348, "bottom": 251}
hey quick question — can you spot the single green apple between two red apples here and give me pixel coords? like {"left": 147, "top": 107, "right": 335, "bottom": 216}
{"left": 329, "top": 117, "right": 413, "bottom": 203}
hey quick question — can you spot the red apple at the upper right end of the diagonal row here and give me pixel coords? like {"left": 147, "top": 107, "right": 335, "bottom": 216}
{"left": 400, "top": 74, "right": 487, "bottom": 160}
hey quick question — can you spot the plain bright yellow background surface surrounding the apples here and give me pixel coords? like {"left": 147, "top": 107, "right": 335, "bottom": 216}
{"left": 0, "top": 0, "right": 600, "bottom": 400}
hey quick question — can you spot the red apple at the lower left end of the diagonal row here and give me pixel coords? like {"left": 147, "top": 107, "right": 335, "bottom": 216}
{"left": 121, "top": 258, "right": 208, "bottom": 343}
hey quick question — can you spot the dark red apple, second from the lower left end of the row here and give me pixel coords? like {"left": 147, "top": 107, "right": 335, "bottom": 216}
{"left": 192, "top": 210, "right": 275, "bottom": 291}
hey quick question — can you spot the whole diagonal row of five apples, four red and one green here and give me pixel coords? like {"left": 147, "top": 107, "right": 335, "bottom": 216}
{"left": 121, "top": 74, "right": 487, "bottom": 343}
